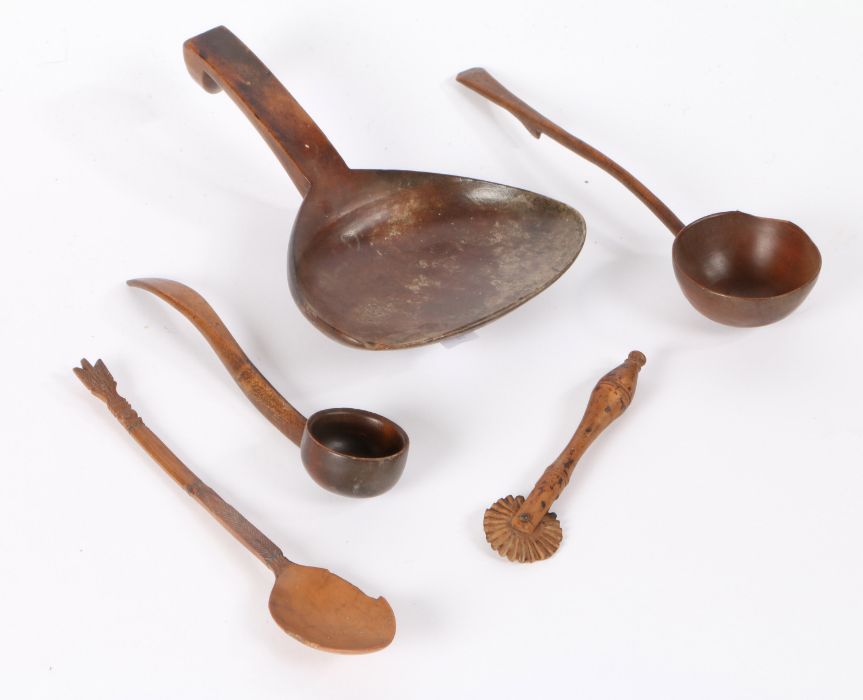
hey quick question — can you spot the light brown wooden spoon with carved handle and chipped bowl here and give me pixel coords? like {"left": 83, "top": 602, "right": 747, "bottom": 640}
{"left": 73, "top": 360, "right": 396, "bottom": 654}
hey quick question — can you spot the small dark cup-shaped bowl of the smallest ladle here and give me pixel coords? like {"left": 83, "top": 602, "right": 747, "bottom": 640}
{"left": 300, "top": 408, "right": 409, "bottom": 498}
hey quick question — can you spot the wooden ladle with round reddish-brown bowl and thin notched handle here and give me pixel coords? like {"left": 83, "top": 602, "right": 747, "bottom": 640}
{"left": 457, "top": 68, "right": 821, "bottom": 326}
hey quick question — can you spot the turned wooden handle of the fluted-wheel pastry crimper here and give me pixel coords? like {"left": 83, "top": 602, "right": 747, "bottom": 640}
{"left": 512, "top": 350, "right": 647, "bottom": 532}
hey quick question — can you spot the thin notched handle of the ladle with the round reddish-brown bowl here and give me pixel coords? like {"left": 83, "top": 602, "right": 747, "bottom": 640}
{"left": 456, "top": 68, "right": 684, "bottom": 236}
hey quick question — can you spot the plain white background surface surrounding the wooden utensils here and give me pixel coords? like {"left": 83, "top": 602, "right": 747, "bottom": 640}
{"left": 0, "top": 0, "right": 863, "bottom": 700}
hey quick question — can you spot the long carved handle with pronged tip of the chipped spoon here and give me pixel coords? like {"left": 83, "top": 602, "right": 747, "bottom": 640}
{"left": 72, "top": 360, "right": 291, "bottom": 574}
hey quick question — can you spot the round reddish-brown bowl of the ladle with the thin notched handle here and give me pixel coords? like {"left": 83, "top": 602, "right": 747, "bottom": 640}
{"left": 671, "top": 211, "right": 821, "bottom": 326}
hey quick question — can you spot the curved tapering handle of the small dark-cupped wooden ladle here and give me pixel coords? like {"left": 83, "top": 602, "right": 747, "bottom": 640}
{"left": 126, "top": 277, "right": 306, "bottom": 445}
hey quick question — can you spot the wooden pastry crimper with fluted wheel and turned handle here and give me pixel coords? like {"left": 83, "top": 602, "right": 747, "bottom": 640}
{"left": 483, "top": 350, "right": 647, "bottom": 562}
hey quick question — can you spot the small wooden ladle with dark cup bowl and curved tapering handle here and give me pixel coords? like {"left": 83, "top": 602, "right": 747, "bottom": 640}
{"left": 127, "top": 278, "right": 409, "bottom": 497}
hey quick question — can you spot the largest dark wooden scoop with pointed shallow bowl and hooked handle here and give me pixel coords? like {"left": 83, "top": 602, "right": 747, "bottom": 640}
{"left": 184, "top": 27, "right": 584, "bottom": 350}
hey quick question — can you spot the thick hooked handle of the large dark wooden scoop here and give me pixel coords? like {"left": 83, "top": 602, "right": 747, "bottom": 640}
{"left": 183, "top": 27, "right": 348, "bottom": 196}
